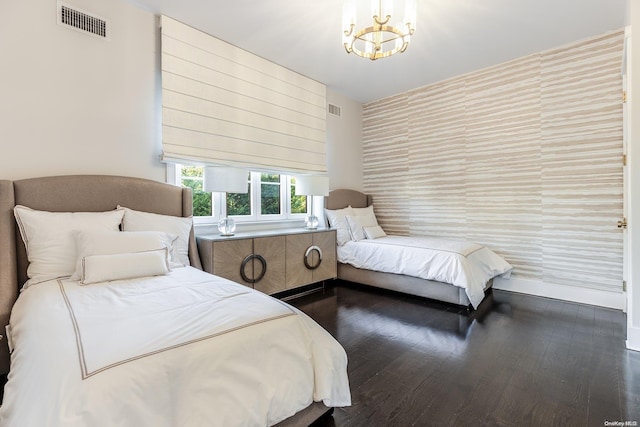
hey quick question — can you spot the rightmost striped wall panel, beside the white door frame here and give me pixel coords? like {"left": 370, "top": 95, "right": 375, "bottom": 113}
{"left": 541, "top": 32, "right": 624, "bottom": 291}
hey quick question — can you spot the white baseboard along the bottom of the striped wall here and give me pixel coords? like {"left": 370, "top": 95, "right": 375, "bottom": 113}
{"left": 493, "top": 277, "right": 625, "bottom": 310}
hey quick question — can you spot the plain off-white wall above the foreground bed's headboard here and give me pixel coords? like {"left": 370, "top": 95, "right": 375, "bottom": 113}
{"left": 0, "top": 0, "right": 165, "bottom": 181}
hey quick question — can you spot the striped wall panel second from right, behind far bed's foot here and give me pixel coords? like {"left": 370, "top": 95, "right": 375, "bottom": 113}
{"left": 463, "top": 55, "right": 543, "bottom": 280}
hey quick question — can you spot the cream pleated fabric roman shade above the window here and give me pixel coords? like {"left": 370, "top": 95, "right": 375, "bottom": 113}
{"left": 161, "top": 16, "right": 327, "bottom": 173}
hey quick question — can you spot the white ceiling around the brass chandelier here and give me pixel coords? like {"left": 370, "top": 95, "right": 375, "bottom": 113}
{"left": 129, "top": 0, "right": 632, "bottom": 103}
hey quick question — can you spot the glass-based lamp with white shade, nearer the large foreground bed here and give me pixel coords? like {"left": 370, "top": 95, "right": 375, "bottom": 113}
{"left": 202, "top": 166, "right": 249, "bottom": 236}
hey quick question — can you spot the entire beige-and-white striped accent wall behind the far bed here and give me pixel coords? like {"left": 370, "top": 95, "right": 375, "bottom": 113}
{"left": 363, "top": 30, "right": 624, "bottom": 292}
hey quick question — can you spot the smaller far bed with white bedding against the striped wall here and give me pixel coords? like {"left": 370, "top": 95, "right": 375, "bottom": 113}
{"left": 325, "top": 189, "right": 512, "bottom": 308}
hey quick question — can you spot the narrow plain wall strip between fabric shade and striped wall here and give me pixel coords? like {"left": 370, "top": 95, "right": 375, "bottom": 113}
{"left": 327, "top": 88, "right": 364, "bottom": 191}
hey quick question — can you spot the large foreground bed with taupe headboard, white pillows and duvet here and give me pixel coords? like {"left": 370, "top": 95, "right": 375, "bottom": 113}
{"left": 0, "top": 176, "right": 350, "bottom": 427}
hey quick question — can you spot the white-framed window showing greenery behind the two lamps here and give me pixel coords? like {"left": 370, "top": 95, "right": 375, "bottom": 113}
{"left": 176, "top": 165, "right": 308, "bottom": 223}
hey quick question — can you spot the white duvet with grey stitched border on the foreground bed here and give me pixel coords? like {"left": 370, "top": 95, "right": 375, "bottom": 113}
{"left": 0, "top": 267, "right": 351, "bottom": 427}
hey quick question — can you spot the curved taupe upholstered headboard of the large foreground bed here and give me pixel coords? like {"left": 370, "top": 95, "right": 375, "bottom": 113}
{"left": 0, "top": 175, "right": 202, "bottom": 373}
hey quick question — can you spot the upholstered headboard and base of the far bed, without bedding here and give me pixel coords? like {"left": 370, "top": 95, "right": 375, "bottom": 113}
{"left": 325, "top": 189, "right": 510, "bottom": 307}
